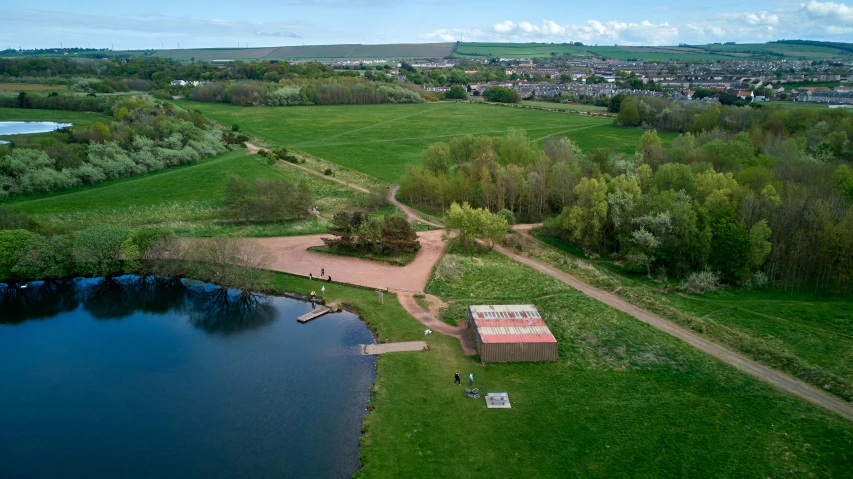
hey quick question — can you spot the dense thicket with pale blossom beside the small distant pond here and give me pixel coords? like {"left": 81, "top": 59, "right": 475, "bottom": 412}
{"left": 0, "top": 95, "right": 226, "bottom": 199}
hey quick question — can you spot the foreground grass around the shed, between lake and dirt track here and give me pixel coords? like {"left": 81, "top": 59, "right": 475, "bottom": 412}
{"left": 276, "top": 253, "right": 853, "bottom": 478}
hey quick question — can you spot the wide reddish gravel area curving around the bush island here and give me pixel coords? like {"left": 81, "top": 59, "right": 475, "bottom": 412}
{"left": 253, "top": 231, "right": 446, "bottom": 293}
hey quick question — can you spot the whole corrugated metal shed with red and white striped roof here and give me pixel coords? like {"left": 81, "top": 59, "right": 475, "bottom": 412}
{"left": 468, "top": 304, "right": 557, "bottom": 362}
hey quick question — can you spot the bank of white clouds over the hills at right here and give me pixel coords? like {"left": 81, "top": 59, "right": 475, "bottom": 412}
{"left": 421, "top": 0, "right": 853, "bottom": 45}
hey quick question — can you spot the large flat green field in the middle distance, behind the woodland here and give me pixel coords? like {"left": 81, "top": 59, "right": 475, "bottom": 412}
{"left": 180, "top": 101, "right": 674, "bottom": 183}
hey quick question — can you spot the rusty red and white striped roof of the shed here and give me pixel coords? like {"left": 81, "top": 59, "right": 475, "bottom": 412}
{"left": 468, "top": 304, "right": 557, "bottom": 343}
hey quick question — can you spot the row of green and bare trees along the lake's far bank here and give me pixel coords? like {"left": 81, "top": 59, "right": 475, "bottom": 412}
{"left": 0, "top": 221, "right": 271, "bottom": 295}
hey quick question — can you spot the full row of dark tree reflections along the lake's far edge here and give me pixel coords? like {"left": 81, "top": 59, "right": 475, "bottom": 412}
{"left": 6, "top": 276, "right": 276, "bottom": 334}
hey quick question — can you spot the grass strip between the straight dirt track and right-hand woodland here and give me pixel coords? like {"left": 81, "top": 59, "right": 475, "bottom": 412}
{"left": 524, "top": 231, "right": 853, "bottom": 401}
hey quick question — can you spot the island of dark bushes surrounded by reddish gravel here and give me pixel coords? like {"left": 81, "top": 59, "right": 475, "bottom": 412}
{"left": 323, "top": 212, "right": 421, "bottom": 254}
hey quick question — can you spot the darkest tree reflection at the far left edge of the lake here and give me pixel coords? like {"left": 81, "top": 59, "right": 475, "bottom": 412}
{"left": 0, "top": 280, "right": 78, "bottom": 324}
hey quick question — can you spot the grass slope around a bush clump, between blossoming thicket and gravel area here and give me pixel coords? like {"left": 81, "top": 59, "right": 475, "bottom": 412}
{"left": 7, "top": 150, "right": 357, "bottom": 236}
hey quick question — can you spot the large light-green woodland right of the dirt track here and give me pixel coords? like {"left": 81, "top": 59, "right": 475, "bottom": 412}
{"left": 399, "top": 130, "right": 853, "bottom": 291}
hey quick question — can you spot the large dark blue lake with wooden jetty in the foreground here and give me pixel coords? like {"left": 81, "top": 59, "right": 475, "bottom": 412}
{"left": 0, "top": 276, "right": 376, "bottom": 479}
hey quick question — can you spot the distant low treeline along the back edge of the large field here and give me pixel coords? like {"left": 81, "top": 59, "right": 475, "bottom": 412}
{"left": 188, "top": 78, "right": 426, "bottom": 106}
